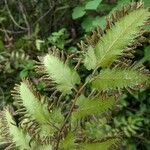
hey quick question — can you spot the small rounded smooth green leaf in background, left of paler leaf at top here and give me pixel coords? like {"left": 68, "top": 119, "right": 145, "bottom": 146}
{"left": 72, "top": 6, "right": 86, "bottom": 19}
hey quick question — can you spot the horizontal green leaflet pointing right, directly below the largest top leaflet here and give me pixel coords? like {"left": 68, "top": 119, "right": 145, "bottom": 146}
{"left": 92, "top": 69, "right": 148, "bottom": 90}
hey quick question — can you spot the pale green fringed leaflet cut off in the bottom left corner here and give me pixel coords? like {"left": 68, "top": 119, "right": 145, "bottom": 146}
{"left": 0, "top": 108, "right": 31, "bottom": 149}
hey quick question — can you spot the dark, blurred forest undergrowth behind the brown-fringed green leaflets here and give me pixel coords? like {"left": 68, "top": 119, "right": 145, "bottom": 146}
{"left": 0, "top": 0, "right": 150, "bottom": 150}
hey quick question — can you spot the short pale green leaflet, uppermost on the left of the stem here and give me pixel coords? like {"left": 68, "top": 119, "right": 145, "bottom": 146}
{"left": 43, "top": 54, "right": 80, "bottom": 94}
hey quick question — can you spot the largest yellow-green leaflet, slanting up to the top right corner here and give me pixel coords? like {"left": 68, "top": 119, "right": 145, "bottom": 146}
{"left": 84, "top": 3, "right": 150, "bottom": 70}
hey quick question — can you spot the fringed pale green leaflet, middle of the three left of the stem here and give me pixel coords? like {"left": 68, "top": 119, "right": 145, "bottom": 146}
{"left": 14, "top": 80, "right": 64, "bottom": 142}
